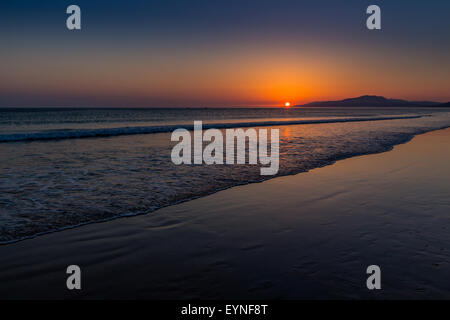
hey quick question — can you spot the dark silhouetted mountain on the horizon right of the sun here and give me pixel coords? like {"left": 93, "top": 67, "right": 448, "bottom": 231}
{"left": 294, "top": 95, "right": 439, "bottom": 107}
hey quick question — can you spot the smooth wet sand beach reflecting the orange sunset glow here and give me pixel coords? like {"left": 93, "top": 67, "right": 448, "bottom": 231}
{"left": 0, "top": 129, "right": 450, "bottom": 299}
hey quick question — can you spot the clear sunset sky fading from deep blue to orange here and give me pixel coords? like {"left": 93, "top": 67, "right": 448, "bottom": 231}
{"left": 0, "top": 0, "right": 450, "bottom": 107}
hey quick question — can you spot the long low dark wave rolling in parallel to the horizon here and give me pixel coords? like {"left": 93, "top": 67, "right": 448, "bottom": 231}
{"left": 0, "top": 116, "right": 424, "bottom": 142}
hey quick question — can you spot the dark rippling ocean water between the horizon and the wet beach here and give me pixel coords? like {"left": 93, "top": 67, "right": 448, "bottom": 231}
{"left": 0, "top": 107, "right": 450, "bottom": 244}
